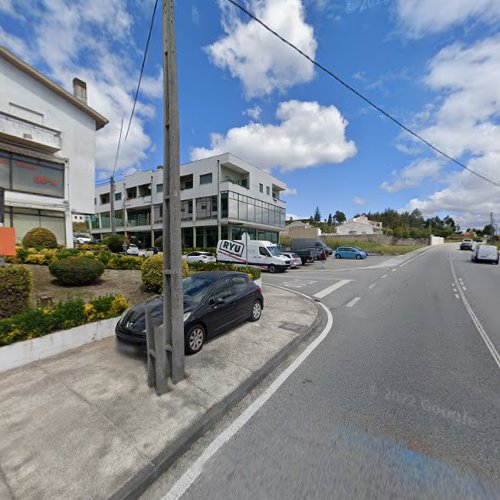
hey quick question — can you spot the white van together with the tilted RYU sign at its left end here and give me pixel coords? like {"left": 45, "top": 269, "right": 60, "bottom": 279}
{"left": 217, "top": 240, "right": 292, "bottom": 273}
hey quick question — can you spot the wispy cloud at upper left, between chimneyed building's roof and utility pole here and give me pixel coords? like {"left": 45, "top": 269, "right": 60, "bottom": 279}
{"left": 0, "top": 0, "right": 161, "bottom": 176}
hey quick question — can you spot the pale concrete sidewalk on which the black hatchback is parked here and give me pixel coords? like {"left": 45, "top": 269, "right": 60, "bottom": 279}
{"left": 0, "top": 286, "right": 321, "bottom": 500}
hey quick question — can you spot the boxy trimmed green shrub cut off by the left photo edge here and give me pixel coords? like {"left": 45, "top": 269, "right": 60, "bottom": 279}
{"left": 0, "top": 266, "right": 33, "bottom": 318}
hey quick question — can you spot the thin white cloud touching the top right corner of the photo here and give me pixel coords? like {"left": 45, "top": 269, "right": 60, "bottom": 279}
{"left": 396, "top": 0, "right": 500, "bottom": 37}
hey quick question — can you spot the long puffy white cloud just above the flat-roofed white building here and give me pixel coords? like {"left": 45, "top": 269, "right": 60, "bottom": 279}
{"left": 191, "top": 100, "right": 356, "bottom": 171}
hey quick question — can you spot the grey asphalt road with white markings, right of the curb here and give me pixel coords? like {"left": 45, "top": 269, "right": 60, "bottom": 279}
{"left": 145, "top": 245, "right": 500, "bottom": 499}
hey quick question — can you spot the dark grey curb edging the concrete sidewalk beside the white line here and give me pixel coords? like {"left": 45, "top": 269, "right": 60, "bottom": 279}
{"left": 110, "top": 285, "right": 326, "bottom": 500}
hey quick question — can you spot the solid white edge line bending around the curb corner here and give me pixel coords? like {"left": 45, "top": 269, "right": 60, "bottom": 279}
{"left": 162, "top": 304, "right": 333, "bottom": 500}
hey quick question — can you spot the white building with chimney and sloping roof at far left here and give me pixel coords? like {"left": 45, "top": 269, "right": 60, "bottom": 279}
{"left": 0, "top": 47, "right": 108, "bottom": 246}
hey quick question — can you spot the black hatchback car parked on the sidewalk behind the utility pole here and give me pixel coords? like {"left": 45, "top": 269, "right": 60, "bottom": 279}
{"left": 115, "top": 271, "right": 264, "bottom": 354}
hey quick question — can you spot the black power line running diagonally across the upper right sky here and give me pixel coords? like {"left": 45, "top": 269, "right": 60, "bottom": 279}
{"left": 226, "top": 0, "right": 500, "bottom": 187}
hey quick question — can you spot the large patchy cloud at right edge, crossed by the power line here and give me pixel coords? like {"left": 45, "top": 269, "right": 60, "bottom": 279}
{"left": 390, "top": 35, "right": 500, "bottom": 223}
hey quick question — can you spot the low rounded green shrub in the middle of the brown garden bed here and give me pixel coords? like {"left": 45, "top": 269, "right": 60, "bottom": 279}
{"left": 49, "top": 257, "right": 104, "bottom": 286}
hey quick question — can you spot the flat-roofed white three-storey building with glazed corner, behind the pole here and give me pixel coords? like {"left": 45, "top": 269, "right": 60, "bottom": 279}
{"left": 91, "top": 153, "right": 286, "bottom": 247}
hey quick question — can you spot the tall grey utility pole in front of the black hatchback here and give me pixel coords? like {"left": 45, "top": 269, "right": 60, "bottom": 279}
{"left": 161, "top": 0, "right": 185, "bottom": 386}
